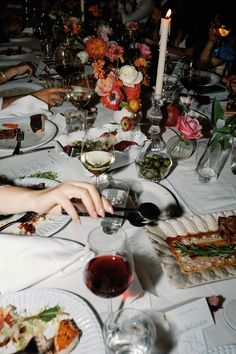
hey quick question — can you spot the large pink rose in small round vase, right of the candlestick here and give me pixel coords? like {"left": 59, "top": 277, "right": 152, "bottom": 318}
{"left": 176, "top": 115, "right": 203, "bottom": 139}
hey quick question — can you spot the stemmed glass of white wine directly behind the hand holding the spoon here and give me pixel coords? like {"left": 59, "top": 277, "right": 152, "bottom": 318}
{"left": 80, "top": 126, "right": 115, "bottom": 184}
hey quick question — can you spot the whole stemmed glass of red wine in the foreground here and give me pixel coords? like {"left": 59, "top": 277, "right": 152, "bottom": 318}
{"left": 84, "top": 230, "right": 134, "bottom": 315}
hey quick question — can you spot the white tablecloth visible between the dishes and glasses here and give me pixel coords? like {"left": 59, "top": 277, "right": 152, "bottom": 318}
{"left": 0, "top": 35, "right": 236, "bottom": 354}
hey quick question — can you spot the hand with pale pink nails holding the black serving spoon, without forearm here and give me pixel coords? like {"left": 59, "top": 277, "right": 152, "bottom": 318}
{"left": 30, "top": 181, "right": 113, "bottom": 222}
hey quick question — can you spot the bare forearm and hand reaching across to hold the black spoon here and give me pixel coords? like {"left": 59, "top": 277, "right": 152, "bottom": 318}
{"left": 0, "top": 181, "right": 113, "bottom": 223}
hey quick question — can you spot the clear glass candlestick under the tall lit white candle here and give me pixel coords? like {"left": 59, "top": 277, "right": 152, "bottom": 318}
{"left": 147, "top": 94, "right": 165, "bottom": 152}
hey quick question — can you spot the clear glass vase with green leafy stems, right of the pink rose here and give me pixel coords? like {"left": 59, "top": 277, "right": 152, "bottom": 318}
{"left": 196, "top": 143, "right": 230, "bottom": 183}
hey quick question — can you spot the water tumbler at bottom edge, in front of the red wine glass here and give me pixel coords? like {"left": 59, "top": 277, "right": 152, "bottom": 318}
{"left": 103, "top": 308, "right": 156, "bottom": 354}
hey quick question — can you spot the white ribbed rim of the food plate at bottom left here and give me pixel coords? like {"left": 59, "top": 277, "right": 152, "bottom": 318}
{"left": 0, "top": 287, "right": 105, "bottom": 354}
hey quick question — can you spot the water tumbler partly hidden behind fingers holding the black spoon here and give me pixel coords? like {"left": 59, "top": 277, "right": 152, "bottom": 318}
{"left": 97, "top": 178, "right": 129, "bottom": 234}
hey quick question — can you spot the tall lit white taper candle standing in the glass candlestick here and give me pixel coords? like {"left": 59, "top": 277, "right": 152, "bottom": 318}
{"left": 155, "top": 10, "right": 171, "bottom": 99}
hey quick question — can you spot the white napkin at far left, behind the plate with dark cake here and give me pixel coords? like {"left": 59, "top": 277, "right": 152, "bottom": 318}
{"left": 0, "top": 95, "right": 52, "bottom": 118}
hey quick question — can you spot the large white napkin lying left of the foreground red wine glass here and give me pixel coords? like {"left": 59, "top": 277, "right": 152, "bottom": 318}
{"left": 0, "top": 234, "right": 84, "bottom": 294}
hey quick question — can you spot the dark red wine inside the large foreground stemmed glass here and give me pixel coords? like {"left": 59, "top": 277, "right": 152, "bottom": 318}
{"left": 84, "top": 254, "right": 133, "bottom": 298}
